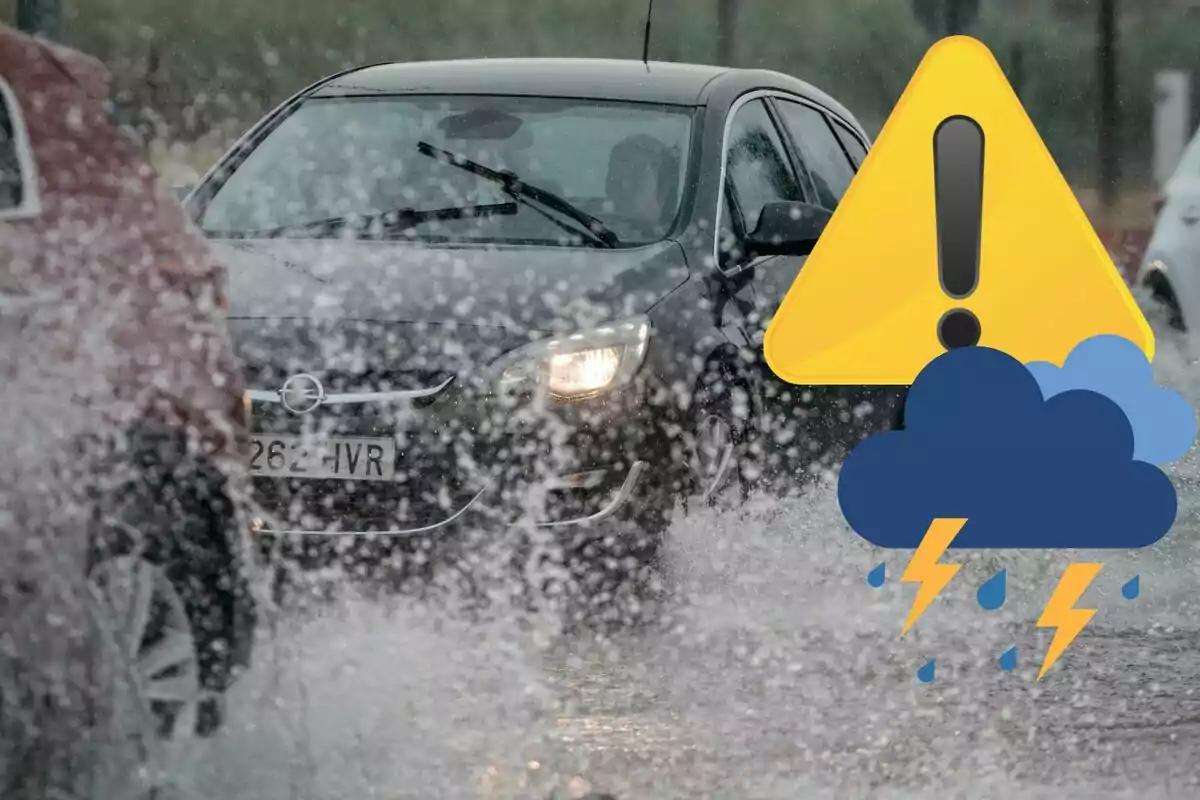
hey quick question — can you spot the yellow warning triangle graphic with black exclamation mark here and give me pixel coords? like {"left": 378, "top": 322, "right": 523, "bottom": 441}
{"left": 763, "top": 36, "right": 1154, "bottom": 385}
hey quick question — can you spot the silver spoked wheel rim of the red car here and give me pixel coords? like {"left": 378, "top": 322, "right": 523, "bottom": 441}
{"left": 90, "top": 555, "right": 202, "bottom": 744}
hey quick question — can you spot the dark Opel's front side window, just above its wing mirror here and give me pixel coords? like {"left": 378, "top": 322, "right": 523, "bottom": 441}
{"left": 726, "top": 100, "right": 804, "bottom": 231}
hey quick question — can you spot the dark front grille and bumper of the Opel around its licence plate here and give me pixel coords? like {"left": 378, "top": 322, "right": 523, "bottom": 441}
{"left": 230, "top": 318, "right": 515, "bottom": 530}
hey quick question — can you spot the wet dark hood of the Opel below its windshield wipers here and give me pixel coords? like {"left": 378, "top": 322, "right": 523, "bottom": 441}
{"left": 215, "top": 240, "right": 688, "bottom": 332}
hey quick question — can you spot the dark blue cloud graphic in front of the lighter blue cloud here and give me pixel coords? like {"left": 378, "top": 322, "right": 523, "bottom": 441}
{"left": 838, "top": 347, "right": 1178, "bottom": 548}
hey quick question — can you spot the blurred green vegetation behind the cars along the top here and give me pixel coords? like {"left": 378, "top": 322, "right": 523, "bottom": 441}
{"left": 7, "top": 0, "right": 1200, "bottom": 203}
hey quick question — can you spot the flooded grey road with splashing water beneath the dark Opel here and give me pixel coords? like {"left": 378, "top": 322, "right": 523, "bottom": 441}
{"left": 171, "top": 316, "right": 1200, "bottom": 800}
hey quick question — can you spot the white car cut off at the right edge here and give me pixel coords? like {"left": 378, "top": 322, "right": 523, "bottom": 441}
{"left": 1136, "top": 121, "right": 1200, "bottom": 331}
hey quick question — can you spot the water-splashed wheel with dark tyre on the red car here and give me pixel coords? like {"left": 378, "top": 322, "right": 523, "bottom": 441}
{"left": 88, "top": 428, "right": 257, "bottom": 740}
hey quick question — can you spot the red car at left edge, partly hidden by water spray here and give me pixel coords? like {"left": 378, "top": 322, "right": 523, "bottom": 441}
{"left": 0, "top": 26, "right": 257, "bottom": 753}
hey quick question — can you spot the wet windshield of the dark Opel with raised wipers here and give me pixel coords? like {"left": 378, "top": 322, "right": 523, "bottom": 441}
{"left": 199, "top": 96, "right": 692, "bottom": 246}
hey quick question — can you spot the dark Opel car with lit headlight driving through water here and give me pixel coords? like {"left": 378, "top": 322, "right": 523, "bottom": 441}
{"left": 186, "top": 59, "right": 906, "bottom": 606}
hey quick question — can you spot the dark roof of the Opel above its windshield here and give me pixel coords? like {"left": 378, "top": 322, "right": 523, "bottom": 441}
{"left": 312, "top": 59, "right": 853, "bottom": 120}
